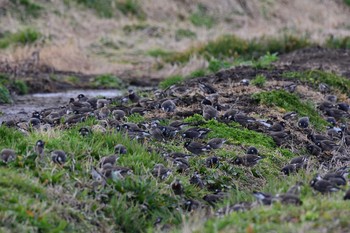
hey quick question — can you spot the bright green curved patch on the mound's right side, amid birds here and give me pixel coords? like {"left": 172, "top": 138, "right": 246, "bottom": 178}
{"left": 252, "top": 90, "right": 327, "bottom": 130}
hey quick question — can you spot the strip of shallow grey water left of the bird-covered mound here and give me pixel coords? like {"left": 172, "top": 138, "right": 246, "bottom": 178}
{"left": 0, "top": 90, "right": 123, "bottom": 122}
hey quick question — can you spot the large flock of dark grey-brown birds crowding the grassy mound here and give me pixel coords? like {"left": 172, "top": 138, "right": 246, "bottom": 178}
{"left": 0, "top": 76, "right": 350, "bottom": 215}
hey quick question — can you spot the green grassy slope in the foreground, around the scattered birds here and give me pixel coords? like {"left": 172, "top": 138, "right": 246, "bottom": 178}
{"left": 0, "top": 69, "right": 350, "bottom": 232}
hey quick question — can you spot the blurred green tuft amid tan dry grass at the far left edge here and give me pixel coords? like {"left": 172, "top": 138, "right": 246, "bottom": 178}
{"left": 0, "top": 28, "right": 41, "bottom": 49}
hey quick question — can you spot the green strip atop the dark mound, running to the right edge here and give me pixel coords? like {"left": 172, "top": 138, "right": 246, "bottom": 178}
{"left": 282, "top": 70, "right": 350, "bottom": 96}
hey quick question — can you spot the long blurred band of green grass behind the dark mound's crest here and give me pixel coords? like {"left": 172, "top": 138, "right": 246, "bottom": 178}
{"left": 165, "top": 35, "right": 311, "bottom": 63}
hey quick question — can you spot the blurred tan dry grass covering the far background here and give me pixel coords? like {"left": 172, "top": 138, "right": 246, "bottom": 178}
{"left": 0, "top": 0, "right": 350, "bottom": 78}
